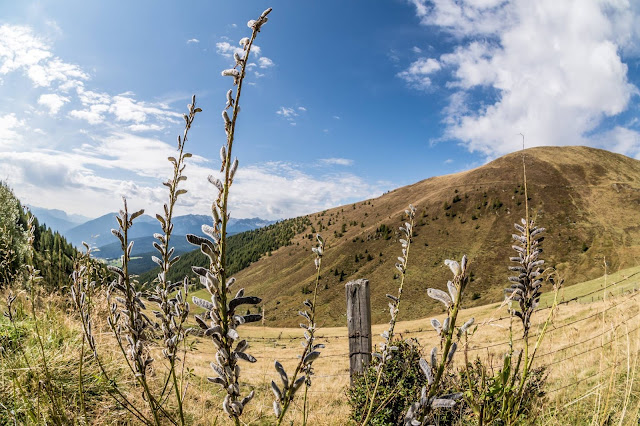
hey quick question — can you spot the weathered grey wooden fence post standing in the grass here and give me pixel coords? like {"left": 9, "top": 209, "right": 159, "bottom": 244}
{"left": 345, "top": 279, "right": 371, "bottom": 385}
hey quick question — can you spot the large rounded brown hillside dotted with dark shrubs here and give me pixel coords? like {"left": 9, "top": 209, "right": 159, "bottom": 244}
{"left": 224, "top": 147, "right": 640, "bottom": 326}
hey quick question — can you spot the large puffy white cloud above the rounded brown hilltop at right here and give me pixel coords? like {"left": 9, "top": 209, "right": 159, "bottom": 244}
{"left": 407, "top": 0, "right": 640, "bottom": 157}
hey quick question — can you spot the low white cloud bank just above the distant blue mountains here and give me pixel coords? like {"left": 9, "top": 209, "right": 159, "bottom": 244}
{"left": 0, "top": 133, "right": 388, "bottom": 219}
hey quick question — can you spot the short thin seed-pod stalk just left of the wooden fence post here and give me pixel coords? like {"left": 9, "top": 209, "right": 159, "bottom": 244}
{"left": 271, "top": 234, "right": 324, "bottom": 425}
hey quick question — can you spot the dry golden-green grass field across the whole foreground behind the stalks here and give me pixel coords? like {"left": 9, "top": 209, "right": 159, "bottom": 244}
{"left": 0, "top": 267, "right": 640, "bottom": 425}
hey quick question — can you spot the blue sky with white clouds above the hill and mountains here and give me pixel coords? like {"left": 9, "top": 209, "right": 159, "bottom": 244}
{"left": 0, "top": 0, "right": 640, "bottom": 219}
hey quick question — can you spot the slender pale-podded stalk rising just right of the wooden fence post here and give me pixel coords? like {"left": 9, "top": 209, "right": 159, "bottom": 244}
{"left": 362, "top": 205, "right": 416, "bottom": 426}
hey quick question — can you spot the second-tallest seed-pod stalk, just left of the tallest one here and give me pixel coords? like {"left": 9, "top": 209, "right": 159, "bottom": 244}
{"left": 147, "top": 95, "right": 202, "bottom": 424}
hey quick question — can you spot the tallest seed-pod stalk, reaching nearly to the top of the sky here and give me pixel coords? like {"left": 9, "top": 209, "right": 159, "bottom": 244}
{"left": 187, "top": 8, "right": 271, "bottom": 425}
